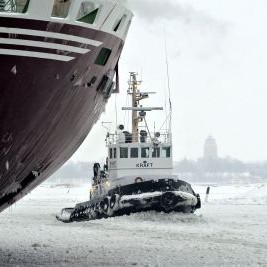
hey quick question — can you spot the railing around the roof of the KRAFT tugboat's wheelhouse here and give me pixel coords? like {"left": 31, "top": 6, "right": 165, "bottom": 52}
{"left": 106, "top": 131, "right": 172, "bottom": 145}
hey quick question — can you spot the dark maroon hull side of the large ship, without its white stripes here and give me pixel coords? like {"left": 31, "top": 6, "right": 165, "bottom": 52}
{"left": 0, "top": 18, "right": 124, "bottom": 214}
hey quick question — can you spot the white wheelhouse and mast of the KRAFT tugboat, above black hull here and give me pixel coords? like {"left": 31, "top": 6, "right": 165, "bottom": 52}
{"left": 107, "top": 73, "right": 174, "bottom": 189}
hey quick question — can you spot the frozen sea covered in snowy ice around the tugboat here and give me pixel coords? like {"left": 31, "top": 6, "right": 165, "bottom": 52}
{"left": 0, "top": 184, "right": 267, "bottom": 267}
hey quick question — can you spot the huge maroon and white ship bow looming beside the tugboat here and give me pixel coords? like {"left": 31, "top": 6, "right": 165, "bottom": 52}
{"left": 0, "top": 0, "right": 133, "bottom": 212}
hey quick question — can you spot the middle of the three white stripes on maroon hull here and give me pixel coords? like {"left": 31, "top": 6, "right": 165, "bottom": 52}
{"left": 0, "top": 38, "right": 90, "bottom": 54}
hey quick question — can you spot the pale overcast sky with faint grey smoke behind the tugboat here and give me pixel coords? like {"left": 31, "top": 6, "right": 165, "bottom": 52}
{"left": 72, "top": 0, "right": 267, "bottom": 161}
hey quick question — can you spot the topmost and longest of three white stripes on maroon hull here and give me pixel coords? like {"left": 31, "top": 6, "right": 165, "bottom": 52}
{"left": 0, "top": 27, "right": 102, "bottom": 46}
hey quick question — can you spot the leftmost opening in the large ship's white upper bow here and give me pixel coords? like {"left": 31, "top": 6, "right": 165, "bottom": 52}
{"left": 0, "top": 0, "right": 30, "bottom": 13}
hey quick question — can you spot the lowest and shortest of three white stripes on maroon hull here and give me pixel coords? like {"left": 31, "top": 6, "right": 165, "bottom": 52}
{"left": 0, "top": 49, "right": 75, "bottom": 62}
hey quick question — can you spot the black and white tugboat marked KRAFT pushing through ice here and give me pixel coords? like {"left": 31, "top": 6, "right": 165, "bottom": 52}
{"left": 57, "top": 73, "right": 201, "bottom": 222}
